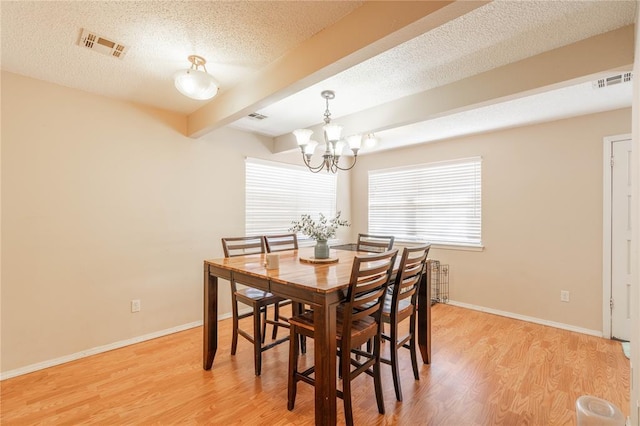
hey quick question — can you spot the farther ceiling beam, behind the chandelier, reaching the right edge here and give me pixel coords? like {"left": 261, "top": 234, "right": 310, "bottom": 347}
{"left": 274, "top": 25, "right": 634, "bottom": 152}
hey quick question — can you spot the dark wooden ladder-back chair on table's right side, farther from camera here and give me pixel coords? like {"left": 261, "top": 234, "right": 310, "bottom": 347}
{"left": 380, "top": 244, "right": 431, "bottom": 401}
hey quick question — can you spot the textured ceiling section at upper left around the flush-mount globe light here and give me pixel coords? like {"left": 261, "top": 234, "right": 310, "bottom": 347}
{"left": 1, "top": 1, "right": 360, "bottom": 114}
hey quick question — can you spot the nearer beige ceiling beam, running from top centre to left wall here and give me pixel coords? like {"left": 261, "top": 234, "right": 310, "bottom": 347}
{"left": 187, "top": 1, "right": 488, "bottom": 137}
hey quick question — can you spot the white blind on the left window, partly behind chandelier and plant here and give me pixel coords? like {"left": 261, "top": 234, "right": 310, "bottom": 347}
{"left": 245, "top": 158, "right": 337, "bottom": 237}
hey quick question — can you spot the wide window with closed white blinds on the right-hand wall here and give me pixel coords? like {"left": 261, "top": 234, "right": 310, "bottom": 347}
{"left": 369, "top": 158, "right": 482, "bottom": 247}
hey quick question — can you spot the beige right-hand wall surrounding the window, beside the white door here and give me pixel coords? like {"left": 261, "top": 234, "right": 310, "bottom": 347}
{"left": 351, "top": 108, "right": 631, "bottom": 331}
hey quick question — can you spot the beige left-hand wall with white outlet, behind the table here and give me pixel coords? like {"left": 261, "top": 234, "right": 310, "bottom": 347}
{"left": 0, "top": 72, "right": 348, "bottom": 372}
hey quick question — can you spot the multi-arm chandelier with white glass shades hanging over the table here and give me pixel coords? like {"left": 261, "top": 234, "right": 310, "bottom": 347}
{"left": 293, "top": 90, "right": 362, "bottom": 173}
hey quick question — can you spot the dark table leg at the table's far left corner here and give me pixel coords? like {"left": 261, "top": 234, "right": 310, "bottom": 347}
{"left": 202, "top": 264, "right": 218, "bottom": 370}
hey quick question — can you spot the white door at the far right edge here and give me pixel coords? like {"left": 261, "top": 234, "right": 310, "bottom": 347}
{"left": 610, "top": 139, "right": 632, "bottom": 340}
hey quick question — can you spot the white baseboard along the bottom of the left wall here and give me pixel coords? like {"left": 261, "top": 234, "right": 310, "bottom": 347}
{"left": 0, "top": 320, "right": 210, "bottom": 381}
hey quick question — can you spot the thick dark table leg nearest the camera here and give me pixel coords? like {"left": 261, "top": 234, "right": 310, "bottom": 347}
{"left": 313, "top": 304, "right": 337, "bottom": 425}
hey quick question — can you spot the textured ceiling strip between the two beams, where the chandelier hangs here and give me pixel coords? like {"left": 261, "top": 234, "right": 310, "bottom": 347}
{"left": 228, "top": 1, "right": 635, "bottom": 136}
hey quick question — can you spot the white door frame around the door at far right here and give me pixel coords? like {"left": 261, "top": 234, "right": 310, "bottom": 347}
{"left": 602, "top": 133, "right": 631, "bottom": 339}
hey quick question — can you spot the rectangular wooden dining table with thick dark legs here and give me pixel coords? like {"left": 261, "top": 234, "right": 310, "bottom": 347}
{"left": 203, "top": 247, "right": 431, "bottom": 425}
